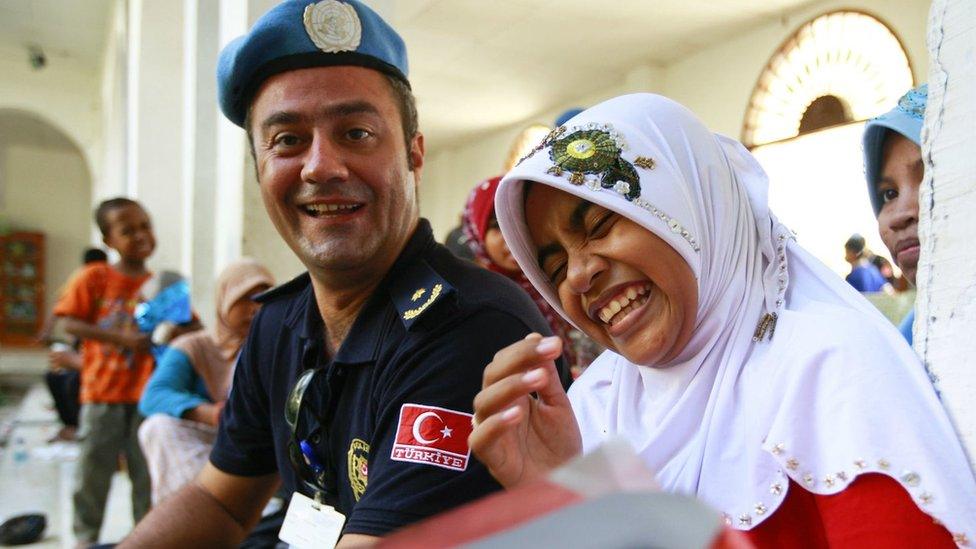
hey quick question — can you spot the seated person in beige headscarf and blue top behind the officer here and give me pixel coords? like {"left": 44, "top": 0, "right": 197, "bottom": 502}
{"left": 139, "top": 258, "right": 274, "bottom": 504}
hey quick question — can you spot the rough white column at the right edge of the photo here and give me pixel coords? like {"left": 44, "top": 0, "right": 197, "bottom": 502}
{"left": 914, "top": 0, "right": 976, "bottom": 466}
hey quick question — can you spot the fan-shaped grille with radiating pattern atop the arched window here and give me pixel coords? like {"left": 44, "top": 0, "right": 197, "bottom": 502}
{"left": 742, "top": 11, "right": 913, "bottom": 147}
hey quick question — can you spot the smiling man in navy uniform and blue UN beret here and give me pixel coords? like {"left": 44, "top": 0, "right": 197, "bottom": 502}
{"left": 126, "top": 0, "right": 564, "bottom": 547}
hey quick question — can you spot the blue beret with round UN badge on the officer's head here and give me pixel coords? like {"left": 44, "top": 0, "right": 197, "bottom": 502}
{"left": 217, "top": 0, "right": 410, "bottom": 127}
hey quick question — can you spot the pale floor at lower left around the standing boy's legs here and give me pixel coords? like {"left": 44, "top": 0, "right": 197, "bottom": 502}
{"left": 0, "top": 378, "right": 132, "bottom": 548}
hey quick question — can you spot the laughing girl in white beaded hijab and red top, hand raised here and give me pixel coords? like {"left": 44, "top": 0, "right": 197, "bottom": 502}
{"left": 470, "top": 94, "right": 976, "bottom": 547}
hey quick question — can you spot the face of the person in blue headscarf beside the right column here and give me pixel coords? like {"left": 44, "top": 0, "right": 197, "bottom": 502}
{"left": 878, "top": 132, "right": 924, "bottom": 285}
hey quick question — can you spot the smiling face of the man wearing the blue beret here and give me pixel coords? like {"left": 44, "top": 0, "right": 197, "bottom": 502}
{"left": 250, "top": 66, "right": 424, "bottom": 278}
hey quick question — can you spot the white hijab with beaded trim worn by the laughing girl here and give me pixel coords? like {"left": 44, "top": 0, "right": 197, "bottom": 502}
{"left": 496, "top": 94, "right": 976, "bottom": 540}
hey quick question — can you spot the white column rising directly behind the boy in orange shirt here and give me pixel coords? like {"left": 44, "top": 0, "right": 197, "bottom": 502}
{"left": 126, "top": 0, "right": 187, "bottom": 270}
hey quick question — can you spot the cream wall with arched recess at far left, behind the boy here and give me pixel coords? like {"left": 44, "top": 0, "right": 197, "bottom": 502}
{"left": 0, "top": 38, "right": 104, "bottom": 309}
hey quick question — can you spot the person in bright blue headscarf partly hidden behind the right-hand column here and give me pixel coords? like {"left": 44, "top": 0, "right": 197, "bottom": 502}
{"left": 864, "top": 84, "right": 928, "bottom": 344}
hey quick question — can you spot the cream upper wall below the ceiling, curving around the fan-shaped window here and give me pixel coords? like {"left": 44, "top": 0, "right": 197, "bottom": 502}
{"left": 420, "top": 0, "right": 929, "bottom": 238}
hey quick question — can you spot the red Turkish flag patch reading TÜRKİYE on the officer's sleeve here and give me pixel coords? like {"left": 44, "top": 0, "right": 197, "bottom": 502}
{"left": 390, "top": 404, "right": 472, "bottom": 471}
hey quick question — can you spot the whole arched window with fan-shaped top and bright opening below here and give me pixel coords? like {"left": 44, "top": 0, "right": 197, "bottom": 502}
{"left": 742, "top": 11, "right": 913, "bottom": 284}
